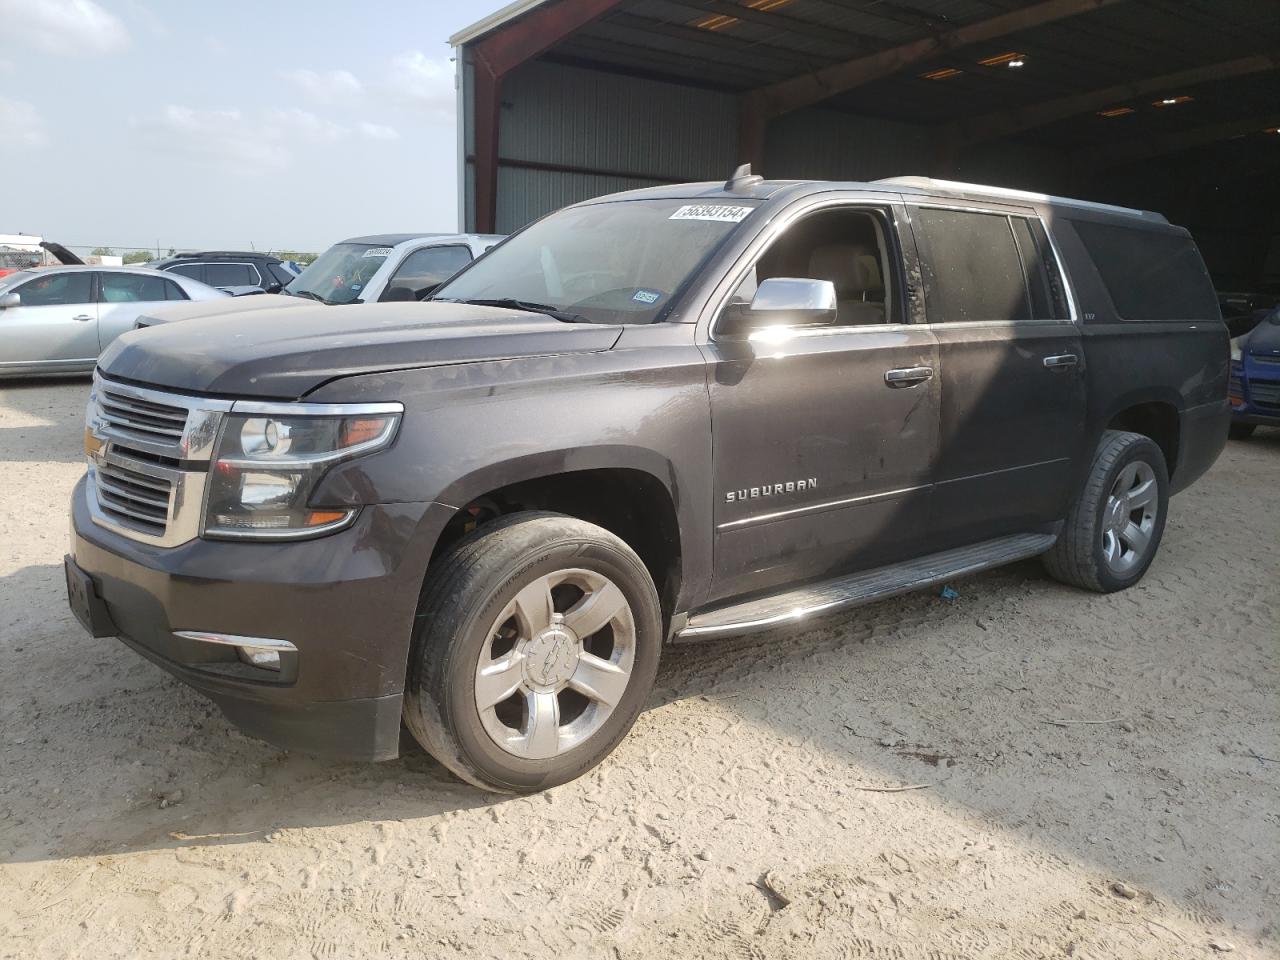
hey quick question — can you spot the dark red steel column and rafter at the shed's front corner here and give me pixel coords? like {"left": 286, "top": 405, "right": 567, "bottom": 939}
{"left": 470, "top": 0, "right": 626, "bottom": 233}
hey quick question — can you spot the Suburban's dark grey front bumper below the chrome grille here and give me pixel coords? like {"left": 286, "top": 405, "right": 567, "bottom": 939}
{"left": 72, "top": 479, "right": 452, "bottom": 760}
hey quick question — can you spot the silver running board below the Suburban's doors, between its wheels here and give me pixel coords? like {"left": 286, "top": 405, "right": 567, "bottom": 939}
{"left": 676, "top": 534, "right": 1057, "bottom": 643}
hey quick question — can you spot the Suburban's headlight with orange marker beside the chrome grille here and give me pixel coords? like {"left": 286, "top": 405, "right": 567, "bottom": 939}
{"left": 205, "top": 403, "right": 401, "bottom": 540}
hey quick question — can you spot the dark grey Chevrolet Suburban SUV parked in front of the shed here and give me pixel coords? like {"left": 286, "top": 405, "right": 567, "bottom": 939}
{"left": 65, "top": 170, "right": 1230, "bottom": 792}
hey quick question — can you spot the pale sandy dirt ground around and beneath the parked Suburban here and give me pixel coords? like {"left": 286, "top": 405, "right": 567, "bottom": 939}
{"left": 0, "top": 380, "right": 1280, "bottom": 960}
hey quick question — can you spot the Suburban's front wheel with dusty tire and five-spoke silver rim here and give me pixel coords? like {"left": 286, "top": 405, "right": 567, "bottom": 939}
{"left": 404, "top": 512, "right": 662, "bottom": 794}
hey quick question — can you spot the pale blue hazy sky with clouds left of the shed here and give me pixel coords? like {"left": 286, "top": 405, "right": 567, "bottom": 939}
{"left": 0, "top": 0, "right": 507, "bottom": 252}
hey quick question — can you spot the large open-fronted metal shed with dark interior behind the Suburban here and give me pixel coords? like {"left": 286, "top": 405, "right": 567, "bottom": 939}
{"left": 451, "top": 0, "right": 1280, "bottom": 289}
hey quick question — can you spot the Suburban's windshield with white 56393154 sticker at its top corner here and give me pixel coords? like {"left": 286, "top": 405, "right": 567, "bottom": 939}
{"left": 433, "top": 200, "right": 756, "bottom": 324}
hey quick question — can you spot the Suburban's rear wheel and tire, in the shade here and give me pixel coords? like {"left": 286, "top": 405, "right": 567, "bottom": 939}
{"left": 1043, "top": 430, "right": 1169, "bottom": 594}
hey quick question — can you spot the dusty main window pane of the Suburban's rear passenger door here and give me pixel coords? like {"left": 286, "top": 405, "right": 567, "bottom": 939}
{"left": 911, "top": 207, "right": 1047, "bottom": 324}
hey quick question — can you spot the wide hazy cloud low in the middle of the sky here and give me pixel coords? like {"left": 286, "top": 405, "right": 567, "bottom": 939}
{"left": 133, "top": 104, "right": 293, "bottom": 174}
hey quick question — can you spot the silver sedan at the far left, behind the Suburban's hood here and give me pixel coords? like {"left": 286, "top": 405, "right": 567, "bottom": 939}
{"left": 0, "top": 266, "right": 230, "bottom": 378}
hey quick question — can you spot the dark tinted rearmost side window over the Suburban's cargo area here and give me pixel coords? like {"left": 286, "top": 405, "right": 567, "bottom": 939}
{"left": 1071, "top": 220, "right": 1219, "bottom": 320}
